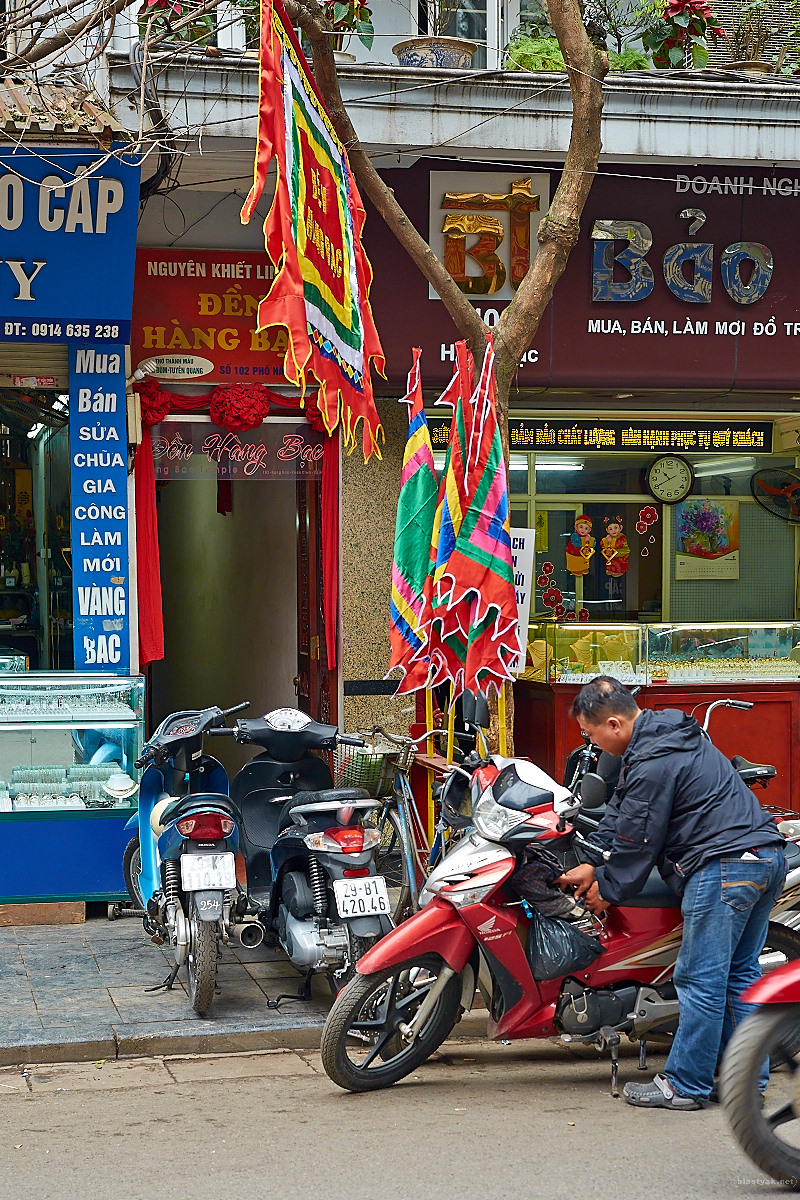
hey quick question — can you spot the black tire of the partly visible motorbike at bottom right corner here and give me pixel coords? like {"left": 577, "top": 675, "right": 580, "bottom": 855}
{"left": 720, "top": 1004, "right": 800, "bottom": 1192}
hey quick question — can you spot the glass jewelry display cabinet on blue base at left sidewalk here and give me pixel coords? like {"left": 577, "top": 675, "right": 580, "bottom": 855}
{"left": 0, "top": 672, "right": 144, "bottom": 904}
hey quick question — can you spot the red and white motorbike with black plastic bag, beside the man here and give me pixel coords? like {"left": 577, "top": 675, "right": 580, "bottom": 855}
{"left": 321, "top": 755, "right": 800, "bottom": 1094}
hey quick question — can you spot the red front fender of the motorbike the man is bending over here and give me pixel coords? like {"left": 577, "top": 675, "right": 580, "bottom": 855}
{"left": 356, "top": 899, "right": 475, "bottom": 974}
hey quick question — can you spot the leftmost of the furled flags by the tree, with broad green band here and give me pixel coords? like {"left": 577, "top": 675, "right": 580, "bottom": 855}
{"left": 387, "top": 349, "right": 438, "bottom": 695}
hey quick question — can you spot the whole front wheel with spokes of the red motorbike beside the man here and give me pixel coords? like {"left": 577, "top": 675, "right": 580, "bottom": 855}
{"left": 320, "top": 954, "right": 462, "bottom": 1092}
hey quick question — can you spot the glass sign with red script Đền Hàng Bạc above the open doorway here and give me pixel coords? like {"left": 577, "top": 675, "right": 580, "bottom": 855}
{"left": 152, "top": 416, "right": 325, "bottom": 482}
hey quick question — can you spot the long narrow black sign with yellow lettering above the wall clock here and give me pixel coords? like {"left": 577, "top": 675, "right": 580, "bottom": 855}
{"left": 428, "top": 416, "right": 772, "bottom": 455}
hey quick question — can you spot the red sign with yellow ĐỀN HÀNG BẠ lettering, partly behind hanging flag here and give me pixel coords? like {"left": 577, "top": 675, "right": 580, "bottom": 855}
{"left": 131, "top": 250, "right": 288, "bottom": 384}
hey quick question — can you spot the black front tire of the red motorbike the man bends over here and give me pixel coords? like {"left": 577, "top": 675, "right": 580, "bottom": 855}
{"left": 320, "top": 955, "right": 462, "bottom": 1092}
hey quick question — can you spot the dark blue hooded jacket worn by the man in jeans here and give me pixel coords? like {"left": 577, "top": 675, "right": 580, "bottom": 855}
{"left": 583, "top": 709, "right": 783, "bottom": 904}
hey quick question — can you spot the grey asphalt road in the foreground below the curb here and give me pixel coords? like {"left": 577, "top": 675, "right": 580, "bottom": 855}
{"left": 0, "top": 1042, "right": 786, "bottom": 1200}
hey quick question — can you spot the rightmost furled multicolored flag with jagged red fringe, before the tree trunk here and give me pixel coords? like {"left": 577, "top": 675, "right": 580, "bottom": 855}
{"left": 423, "top": 336, "right": 519, "bottom": 695}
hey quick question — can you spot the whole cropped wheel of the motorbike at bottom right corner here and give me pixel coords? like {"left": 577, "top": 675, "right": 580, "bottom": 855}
{"left": 720, "top": 1004, "right": 800, "bottom": 1192}
